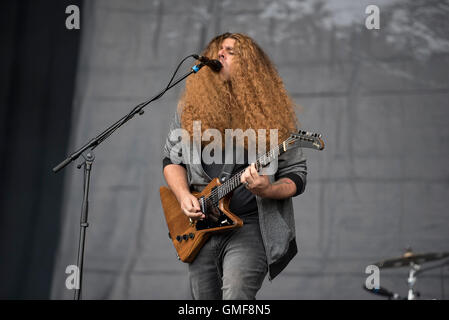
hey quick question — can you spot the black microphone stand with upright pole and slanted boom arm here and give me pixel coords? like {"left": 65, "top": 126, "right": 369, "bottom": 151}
{"left": 52, "top": 60, "right": 205, "bottom": 300}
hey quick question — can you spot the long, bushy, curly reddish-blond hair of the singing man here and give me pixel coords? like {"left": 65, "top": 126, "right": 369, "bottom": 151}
{"left": 178, "top": 33, "right": 299, "bottom": 148}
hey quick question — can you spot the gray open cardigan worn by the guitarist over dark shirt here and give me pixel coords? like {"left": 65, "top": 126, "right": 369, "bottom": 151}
{"left": 162, "top": 112, "right": 307, "bottom": 281}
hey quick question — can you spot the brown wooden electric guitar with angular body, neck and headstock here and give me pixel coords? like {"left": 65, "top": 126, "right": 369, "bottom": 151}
{"left": 159, "top": 131, "right": 324, "bottom": 263}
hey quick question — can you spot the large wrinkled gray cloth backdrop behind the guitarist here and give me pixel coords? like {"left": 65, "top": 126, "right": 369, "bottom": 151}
{"left": 52, "top": 0, "right": 449, "bottom": 299}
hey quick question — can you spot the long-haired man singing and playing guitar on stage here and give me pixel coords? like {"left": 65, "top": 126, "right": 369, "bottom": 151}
{"left": 163, "top": 33, "right": 307, "bottom": 299}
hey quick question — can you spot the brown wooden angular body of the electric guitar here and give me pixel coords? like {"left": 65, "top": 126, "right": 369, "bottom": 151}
{"left": 159, "top": 178, "right": 243, "bottom": 263}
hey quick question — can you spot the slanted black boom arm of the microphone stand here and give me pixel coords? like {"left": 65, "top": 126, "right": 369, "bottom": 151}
{"left": 52, "top": 63, "right": 204, "bottom": 173}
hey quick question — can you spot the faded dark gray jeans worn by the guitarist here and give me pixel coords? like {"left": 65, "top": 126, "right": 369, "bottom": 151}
{"left": 189, "top": 214, "right": 268, "bottom": 300}
